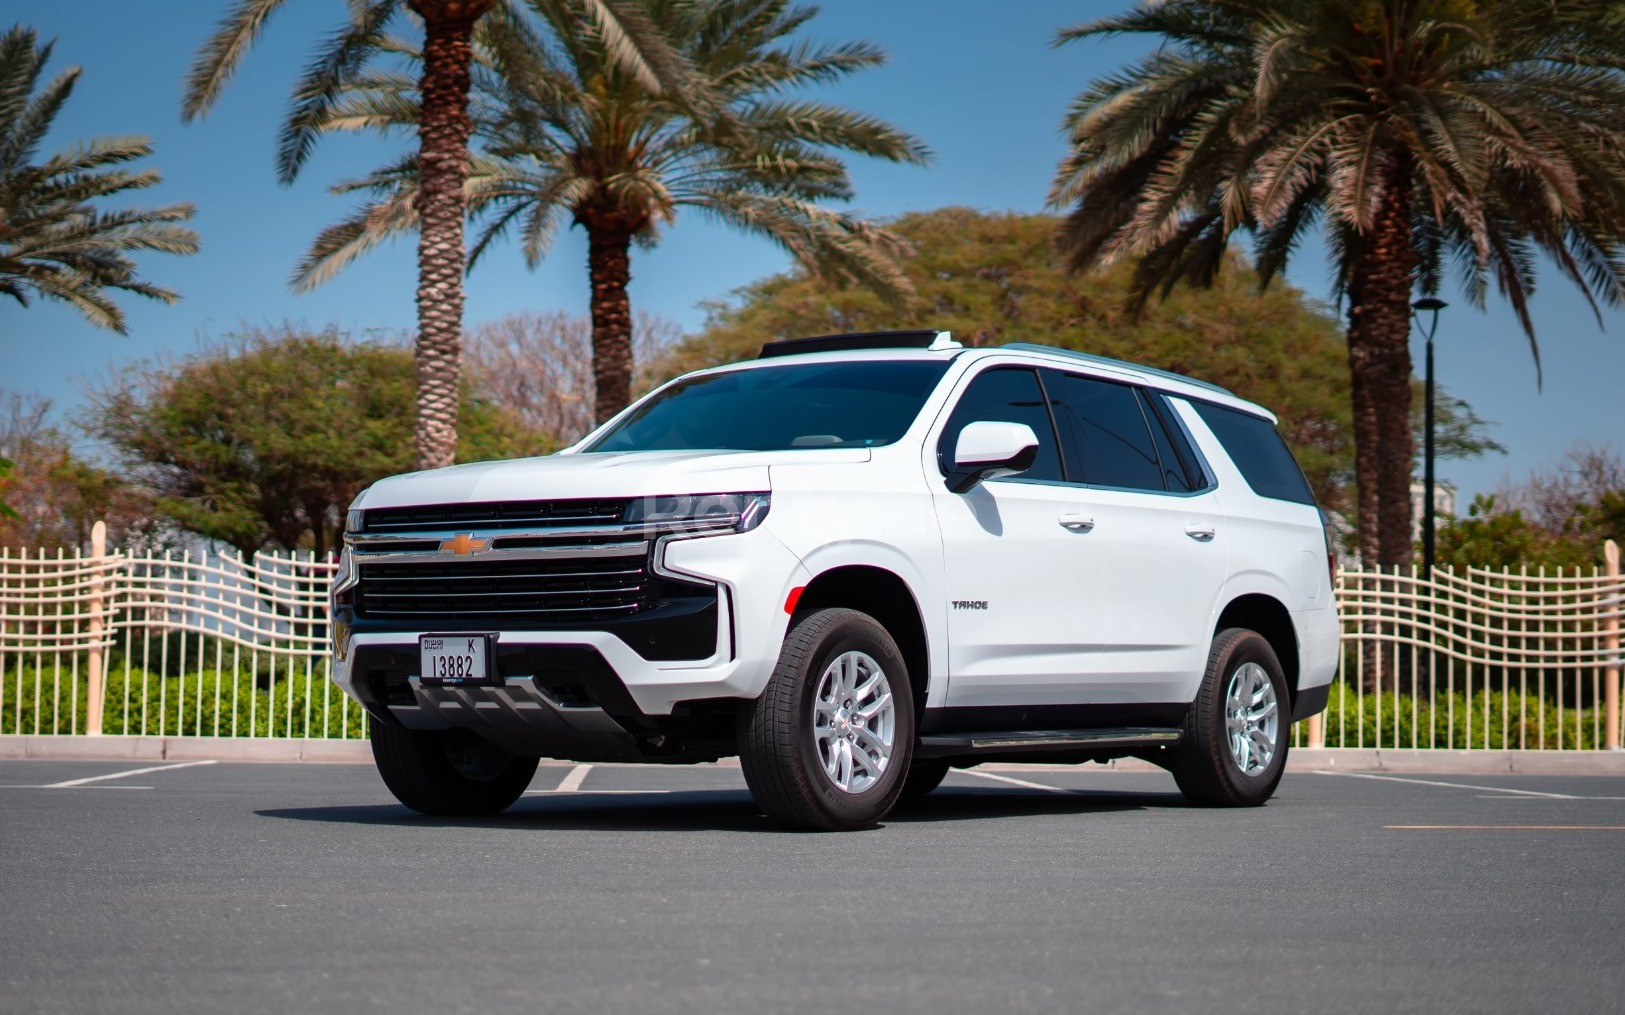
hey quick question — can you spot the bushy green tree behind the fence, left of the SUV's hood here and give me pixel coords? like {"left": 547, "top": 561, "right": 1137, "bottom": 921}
{"left": 85, "top": 325, "right": 551, "bottom": 555}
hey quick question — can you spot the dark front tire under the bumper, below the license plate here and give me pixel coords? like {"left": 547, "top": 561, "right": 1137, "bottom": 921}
{"left": 372, "top": 723, "right": 536, "bottom": 817}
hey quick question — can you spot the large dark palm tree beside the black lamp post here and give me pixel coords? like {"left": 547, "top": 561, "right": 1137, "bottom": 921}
{"left": 1050, "top": 0, "right": 1625, "bottom": 565}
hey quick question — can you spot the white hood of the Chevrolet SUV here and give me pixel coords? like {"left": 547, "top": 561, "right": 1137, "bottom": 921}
{"left": 351, "top": 448, "right": 871, "bottom": 508}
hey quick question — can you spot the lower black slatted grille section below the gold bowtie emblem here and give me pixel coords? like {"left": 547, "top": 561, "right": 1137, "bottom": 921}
{"left": 356, "top": 544, "right": 652, "bottom": 624}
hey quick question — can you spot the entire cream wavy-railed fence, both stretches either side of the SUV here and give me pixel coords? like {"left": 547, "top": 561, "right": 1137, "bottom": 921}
{"left": 0, "top": 544, "right": 1625, "bottom": 750}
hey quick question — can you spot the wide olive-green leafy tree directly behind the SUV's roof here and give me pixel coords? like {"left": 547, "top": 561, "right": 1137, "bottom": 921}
{"left": 657, "top": 208, "right": 1498, "bottom": 508}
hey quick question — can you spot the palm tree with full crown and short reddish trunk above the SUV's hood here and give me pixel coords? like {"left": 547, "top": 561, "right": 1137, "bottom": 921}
{"left": 296, "top": 0, "right": 930, "bottom": 421}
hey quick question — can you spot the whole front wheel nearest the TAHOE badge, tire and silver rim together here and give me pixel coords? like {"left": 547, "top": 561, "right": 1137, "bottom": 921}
{"left": 739, "top": 609, "right": 915, "bottom": 831}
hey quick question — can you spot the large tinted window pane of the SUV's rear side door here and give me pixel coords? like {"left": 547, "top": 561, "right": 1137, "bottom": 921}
{"left": 1045, "top": 370, "right": 1165, "bottom": 490}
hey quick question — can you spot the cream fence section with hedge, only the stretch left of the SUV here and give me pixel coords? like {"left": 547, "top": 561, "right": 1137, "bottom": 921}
{"left": 0, "top": 526, "right": 354, "bottom": 737}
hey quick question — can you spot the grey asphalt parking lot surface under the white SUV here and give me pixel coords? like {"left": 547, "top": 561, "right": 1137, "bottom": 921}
{"left": 0, "top": 760, "right": 1625, "bottom": 1015}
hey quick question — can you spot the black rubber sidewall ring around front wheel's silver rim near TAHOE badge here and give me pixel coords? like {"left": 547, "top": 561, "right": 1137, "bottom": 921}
{"left": 793, "top": 612, "right": 915, "bottom": 823}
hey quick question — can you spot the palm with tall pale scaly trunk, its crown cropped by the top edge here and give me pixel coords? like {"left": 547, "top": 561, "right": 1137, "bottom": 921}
{"left": 182, "top": 0, "right": 678, "bottom": 469}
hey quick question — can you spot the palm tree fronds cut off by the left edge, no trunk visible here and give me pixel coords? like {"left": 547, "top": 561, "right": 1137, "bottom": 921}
{"left": 0, "top": 24, "right": 198, "bottom": 335}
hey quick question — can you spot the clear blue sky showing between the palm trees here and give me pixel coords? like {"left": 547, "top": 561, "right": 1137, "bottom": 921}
{"left": 0, "top": 0, "right": 1625, "bottom": 494}
